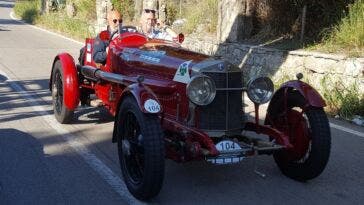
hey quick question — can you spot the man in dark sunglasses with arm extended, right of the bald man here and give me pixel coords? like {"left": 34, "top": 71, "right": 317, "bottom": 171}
{"left": 139, "top": 9, "right": 177, "bottom": 41}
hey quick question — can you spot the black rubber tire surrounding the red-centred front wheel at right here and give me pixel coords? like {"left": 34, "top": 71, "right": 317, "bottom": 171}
{"left": 268, "top": 92, "right": 331, "bottom": 181}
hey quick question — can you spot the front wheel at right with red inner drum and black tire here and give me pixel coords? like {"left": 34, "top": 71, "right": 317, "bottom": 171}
{"left": 266, "top": 92, "right": 331, "bottom": 181}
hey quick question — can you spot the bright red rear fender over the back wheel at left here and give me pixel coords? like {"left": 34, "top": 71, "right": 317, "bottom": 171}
{"left": 49, "top": 53, "right": 80, "bottom": 110}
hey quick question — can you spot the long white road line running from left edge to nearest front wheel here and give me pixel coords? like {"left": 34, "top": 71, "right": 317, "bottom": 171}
{"left": 0, "top": 70, "right": 145, "bottom": 205}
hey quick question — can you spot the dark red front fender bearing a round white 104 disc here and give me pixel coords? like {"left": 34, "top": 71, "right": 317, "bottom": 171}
{"left": 112, "top": 83, "right": 163, "bottom": 143}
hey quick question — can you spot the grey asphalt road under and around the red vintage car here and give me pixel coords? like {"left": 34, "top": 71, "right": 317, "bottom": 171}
{"left": 0, "top": 0, "right": 364, "bottom": 205}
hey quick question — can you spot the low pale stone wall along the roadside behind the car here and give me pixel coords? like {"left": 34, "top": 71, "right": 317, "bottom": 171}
{"left": 182, "top": 37, "right": 364, "bottom": 94}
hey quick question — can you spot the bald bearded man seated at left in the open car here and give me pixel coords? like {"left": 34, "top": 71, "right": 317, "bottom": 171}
{"left": 92, "top": 10, "right": 123, "bottom": 64}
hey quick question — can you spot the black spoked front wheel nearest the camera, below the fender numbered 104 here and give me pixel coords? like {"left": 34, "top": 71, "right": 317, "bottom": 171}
{"left": 116, "top": 96, "right": 165, "bottom": 200}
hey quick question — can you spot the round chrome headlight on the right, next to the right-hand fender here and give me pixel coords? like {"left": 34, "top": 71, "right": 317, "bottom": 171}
{"left": 246, "top": 76, "right": 274, "bottom": 104}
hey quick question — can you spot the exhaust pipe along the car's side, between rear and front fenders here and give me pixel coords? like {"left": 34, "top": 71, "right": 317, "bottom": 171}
{"left": 80, "top": 66, "right": 125, "bottom": 84}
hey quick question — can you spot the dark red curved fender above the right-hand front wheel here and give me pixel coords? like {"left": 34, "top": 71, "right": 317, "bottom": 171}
{"left": 272, "top": 80, "right": 326, "bottom": 107}
